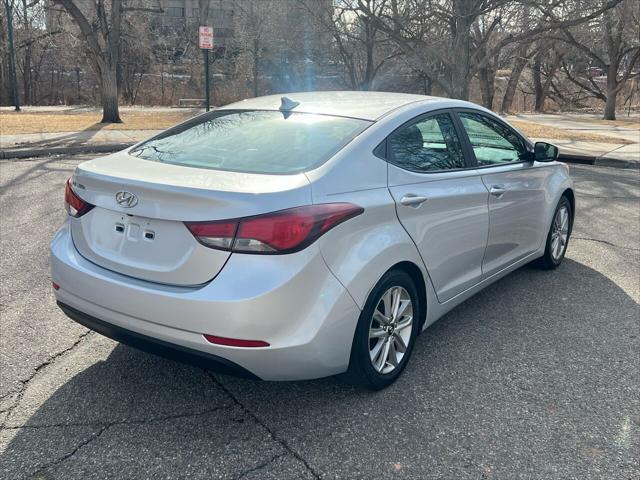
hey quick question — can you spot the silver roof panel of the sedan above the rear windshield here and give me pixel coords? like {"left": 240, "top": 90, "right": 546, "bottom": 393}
{"left": 219, "top": 91, "right": 476, "bottom": 120}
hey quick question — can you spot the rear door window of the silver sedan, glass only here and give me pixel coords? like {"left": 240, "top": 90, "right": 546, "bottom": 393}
{"left": 388, "top": 113, "right": 466, "bottom": 172}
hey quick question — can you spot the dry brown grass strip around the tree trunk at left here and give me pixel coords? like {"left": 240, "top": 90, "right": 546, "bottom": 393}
{"left": 0, "top": 111, "right": 193, "bottom": 135}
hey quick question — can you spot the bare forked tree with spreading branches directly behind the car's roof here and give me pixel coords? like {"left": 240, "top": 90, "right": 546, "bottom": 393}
{"left": 358, "top": 0, "right": 622, "bottom": 99}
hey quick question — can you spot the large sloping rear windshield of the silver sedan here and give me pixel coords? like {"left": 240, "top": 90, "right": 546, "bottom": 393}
{"left": 129, "top": 110, "right": 371, "bottom": 173}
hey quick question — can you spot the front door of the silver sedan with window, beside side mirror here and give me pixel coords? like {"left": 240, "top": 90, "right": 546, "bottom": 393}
{"left": 457, "top": 110, "right": 552, "bottom": 277}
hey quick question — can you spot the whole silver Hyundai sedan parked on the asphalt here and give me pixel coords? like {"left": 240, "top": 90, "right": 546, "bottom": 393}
{"left": 51, "top": 92, "right": 575, "bottom": 389}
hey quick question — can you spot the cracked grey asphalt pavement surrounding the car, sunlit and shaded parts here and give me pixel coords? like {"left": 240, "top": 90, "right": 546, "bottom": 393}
{"left": 0, "top": 156, "right": 640, "bottom": 480}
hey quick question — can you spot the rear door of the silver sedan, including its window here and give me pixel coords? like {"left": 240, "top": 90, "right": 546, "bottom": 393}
{"left": 385, "top": 111, "right": 489, "bottom": 302}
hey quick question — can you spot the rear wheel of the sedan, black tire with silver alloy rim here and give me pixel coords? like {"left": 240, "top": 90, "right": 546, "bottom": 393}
{"left": 345, "top": 270, "right": 422, "bottom": 390}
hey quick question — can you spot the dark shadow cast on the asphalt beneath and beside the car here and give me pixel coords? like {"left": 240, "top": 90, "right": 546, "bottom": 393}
{"left": 0, "top": 259, "right": 640, "bottom": 479}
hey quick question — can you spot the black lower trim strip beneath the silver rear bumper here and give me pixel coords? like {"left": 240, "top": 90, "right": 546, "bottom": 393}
{"left": 57, "top": 302, "right": 258, "bottom": 379}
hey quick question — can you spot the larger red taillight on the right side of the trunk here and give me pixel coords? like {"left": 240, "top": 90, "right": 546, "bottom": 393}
{"left": 185, "top": 203, "right": 364, "bottom": 254}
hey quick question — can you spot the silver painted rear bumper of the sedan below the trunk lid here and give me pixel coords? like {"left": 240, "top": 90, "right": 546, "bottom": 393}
{"left": 51, "top": 223, "right": 360, "bottom": 380}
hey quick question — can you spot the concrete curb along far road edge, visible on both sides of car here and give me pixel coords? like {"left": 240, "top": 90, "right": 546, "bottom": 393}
{"left": 0, "top": 143, "right": 640, "bottom": 170}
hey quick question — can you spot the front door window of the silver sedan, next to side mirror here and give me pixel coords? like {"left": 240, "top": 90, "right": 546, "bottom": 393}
{"left": 458, "top": 112, "right": 527, "bottom": 167}
